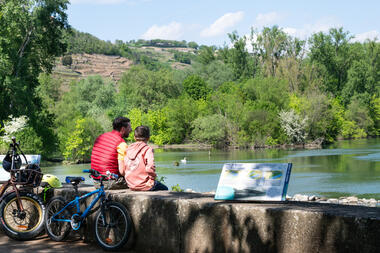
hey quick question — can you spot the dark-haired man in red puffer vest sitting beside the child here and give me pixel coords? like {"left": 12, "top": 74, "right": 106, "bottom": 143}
{"left": 91, "top": 117, "right": 132, "bottom": 189}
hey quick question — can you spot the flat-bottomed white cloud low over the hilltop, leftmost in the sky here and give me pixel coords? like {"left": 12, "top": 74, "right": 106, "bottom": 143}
{"left": 141, "top": 22, "right": 184, "bottom": 40}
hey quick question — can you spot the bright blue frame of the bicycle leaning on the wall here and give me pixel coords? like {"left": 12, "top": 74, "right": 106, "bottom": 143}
{"left": 51, "top": 185, "right": 106, "bottom": 230}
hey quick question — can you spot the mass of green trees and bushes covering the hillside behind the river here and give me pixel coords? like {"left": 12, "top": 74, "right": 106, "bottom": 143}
{"left": 0, "top": 10, "right": 380, "bottom": 162}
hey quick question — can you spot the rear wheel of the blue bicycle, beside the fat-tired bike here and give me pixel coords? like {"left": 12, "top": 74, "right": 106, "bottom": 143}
{"left": 45, "top": 197, "right": 71, "bottom": 242}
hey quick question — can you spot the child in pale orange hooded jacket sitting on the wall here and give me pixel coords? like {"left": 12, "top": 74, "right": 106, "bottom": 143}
{"left": 121, "top": 126, "right": 168, "bottom": 191}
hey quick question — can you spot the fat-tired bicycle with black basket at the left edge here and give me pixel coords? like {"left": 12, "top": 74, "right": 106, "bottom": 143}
{"left": 0, "top": 137, "right": 45, "bottom": 240}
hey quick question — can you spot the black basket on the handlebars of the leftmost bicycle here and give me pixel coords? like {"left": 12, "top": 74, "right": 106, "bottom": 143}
{"left": 11, "top": 163, "right": 43, "bottom": 187}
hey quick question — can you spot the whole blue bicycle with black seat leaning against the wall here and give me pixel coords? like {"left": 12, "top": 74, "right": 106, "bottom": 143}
{"left": 45, "top": 169, "right": 132, "bottom": 250}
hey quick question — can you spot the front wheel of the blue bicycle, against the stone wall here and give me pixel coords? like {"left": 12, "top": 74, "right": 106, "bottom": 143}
{"left": 95, "top": 202, "right": 132, "bottom": 250}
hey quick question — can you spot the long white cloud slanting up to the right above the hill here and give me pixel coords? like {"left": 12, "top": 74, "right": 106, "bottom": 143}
{"left": 201, "top": 11, "right": 244, "bottom": 37}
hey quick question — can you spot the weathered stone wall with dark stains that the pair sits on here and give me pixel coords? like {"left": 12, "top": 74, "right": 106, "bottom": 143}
{"left": 54, "top": 187, "right": 380, "bottom": 253}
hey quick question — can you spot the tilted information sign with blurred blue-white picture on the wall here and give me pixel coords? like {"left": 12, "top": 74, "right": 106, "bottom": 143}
{"left": 215, "top": 163, "right": 292, "bottom": 201}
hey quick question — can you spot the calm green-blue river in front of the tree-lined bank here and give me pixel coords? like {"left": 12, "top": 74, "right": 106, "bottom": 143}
{"left": 42, "top": 138, "right": 380, "bottom": 199}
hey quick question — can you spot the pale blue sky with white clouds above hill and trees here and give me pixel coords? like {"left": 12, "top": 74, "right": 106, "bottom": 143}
{"left": 67, "top": 0, "right": 380, "bottom": 46}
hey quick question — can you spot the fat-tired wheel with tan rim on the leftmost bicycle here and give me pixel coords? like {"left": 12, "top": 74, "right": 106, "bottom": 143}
{"left": 0, "top": 192, "right": 45, "bottom": 240}
